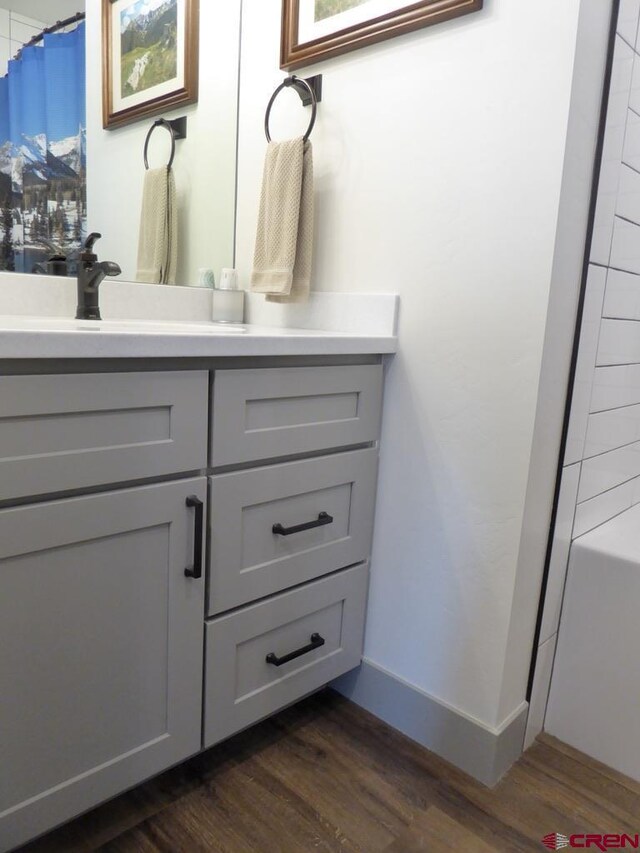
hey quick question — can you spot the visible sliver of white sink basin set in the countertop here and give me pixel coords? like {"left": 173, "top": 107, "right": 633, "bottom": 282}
{"left": 0, "top": 316, "right": 247, "bottom": 336}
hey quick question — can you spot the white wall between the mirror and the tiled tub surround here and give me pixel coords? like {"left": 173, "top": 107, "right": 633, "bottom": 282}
{"left": 237, "top": 0, "right": 579, "bottom": 726}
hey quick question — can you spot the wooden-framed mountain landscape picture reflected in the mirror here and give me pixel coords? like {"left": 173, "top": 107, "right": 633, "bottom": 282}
{"left": 102, "top": 0, "right": 199, "bottom": 129}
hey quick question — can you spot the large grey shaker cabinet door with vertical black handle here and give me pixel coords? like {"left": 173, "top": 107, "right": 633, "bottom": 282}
{"left": 0, "top": 478, "right": 206, "bottom": 851}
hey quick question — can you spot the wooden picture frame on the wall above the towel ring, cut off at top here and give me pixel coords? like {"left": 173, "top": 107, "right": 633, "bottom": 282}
{"left": 280, "top": 0, "right": 483, "bottom": 70}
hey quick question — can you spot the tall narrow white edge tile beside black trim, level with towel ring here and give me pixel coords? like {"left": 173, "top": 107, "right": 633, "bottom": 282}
{"left": 590, "top": 36, "right": 640, "bottom": 265}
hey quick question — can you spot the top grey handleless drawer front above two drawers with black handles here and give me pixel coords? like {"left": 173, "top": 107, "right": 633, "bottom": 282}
{"left": 211, "top": 364, "right": 382, "bottom": 467}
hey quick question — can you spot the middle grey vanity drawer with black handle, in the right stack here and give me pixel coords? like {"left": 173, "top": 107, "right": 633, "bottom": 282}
{"left": 208, "top": 448, "right": 378, "bottom": 616}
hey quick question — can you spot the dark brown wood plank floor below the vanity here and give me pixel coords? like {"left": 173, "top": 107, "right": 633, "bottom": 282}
{"left": 17, "top": 691, "right": 640, "bottom": 853}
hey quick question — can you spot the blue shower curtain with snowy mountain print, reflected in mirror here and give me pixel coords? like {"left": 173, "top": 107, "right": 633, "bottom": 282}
{"left": 0, "top": 24, "right": 87, "bottom": 272}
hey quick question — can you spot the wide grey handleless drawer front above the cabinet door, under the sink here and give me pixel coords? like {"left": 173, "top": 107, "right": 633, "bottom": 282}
{"left": 0, "top": 371, "right": 208, "bottom": 500}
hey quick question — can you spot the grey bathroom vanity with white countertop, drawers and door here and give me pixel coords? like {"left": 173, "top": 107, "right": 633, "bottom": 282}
{"left": 0, "top": 318, "right": 395, "bottom": 851}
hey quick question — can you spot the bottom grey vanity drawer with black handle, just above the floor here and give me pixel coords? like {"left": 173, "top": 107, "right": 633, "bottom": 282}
{"left": 204, "top": 564, "right": 368, "bottom": 748}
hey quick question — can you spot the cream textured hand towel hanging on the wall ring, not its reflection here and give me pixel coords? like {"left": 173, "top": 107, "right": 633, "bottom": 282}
{"left": 251, "top": 137, "right": 313, "bottom": 302}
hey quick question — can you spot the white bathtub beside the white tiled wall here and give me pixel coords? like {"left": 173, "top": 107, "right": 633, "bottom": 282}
{"left": 545, "top": 505, "right": 640, "bottom": 781}
